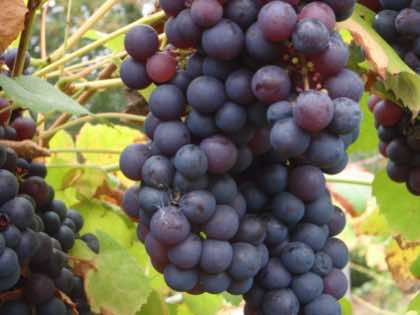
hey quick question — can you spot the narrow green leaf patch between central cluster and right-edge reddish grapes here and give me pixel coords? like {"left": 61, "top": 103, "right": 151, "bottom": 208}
{"left": 349, "top": 93, "right": 379, "bottom": 154}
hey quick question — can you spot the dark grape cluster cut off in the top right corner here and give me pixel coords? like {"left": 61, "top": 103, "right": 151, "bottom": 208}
{"left": 373, "top": 0, "right": 420, "bottom": 73}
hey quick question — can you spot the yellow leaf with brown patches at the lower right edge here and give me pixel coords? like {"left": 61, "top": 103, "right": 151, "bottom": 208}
{"left": 385, "top": 240, "right": 420, "bottom": 292}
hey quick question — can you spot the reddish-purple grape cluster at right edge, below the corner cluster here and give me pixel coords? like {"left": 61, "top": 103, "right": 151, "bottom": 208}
{"left": 369, "top": 96, "right": 420, "bottom": 196}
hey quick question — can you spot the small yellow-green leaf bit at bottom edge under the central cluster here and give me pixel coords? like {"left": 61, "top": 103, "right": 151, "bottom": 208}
{"left": 184, "top": 294, "right": 223, "bottom": 315}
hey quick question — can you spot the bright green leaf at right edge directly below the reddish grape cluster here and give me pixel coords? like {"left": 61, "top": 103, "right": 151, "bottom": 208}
{"left": 373, "top": 170, "right": 420, "bottom": 240}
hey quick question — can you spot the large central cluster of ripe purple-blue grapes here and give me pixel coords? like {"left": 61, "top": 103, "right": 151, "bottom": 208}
{"left": 120, "top": 0, "right": 364, "bottom": 315}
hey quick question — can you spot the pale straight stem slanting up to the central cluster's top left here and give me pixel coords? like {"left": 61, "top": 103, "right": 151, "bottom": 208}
{"left": 34, "top": 11, "right": 166, "bottom": 76}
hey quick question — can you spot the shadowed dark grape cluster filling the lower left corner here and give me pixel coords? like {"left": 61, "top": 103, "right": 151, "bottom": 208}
{"left": 0, "top": 147, "right": 99, "bottom": 315}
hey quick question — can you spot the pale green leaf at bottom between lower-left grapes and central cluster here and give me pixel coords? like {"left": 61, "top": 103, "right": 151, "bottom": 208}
{"left": 85, "top": 231, "right": 152, "bottom": 315}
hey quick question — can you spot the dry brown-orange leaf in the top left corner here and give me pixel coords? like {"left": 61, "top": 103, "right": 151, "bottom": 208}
{"left": 0, "top": 0, "right": 28, "bottom": 53}
